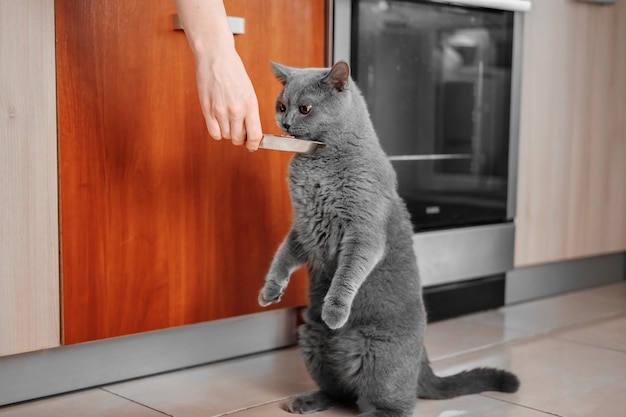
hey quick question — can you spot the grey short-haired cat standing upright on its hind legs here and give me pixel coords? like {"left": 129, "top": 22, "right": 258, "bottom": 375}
{"left": 259, "top": 62, "right": 519, "bottom": 416}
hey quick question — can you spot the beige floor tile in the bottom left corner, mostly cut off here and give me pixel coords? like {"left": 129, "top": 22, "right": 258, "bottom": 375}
{"left": 0, "top": 389, "right": 163, "bottom": 417}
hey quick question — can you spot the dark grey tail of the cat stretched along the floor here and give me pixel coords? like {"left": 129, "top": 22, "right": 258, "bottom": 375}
{"left": 418, "top": 355, "right": 519, "bottom": 400}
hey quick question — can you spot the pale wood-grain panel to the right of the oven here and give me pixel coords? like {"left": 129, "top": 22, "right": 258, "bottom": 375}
{"left": 515, "top": 0, "right": 626, "bottom": 266}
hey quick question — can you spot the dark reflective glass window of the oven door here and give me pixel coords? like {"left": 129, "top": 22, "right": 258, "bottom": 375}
{"left": 351, "top": 0, "right": 513, "bottom": 231}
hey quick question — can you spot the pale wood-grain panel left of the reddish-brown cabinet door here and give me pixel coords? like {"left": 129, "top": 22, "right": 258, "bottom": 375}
{"left": 0, "top": 0, "right": 60, "bottom": 356}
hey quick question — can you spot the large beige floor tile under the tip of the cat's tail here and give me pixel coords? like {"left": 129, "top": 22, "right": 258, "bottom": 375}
{"left": 434, "top": 337, "right": 626, "bottom": 417}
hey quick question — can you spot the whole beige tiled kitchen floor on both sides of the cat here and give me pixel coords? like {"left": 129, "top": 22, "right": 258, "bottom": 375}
{"left": 0, "top": 282, "right": 626, "bottom": 417}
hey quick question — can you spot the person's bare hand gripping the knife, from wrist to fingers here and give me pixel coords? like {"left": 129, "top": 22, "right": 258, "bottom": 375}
{"left": 196, "top": 49, "right": 263, "bottom": 151}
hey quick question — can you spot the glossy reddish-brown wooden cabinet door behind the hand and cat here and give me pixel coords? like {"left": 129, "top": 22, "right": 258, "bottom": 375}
{"left": 55, "top": 0, "right": 325, "bottom": 344}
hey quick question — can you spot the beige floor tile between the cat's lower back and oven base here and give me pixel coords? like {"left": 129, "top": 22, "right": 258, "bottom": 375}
{"left": 424, "top": 319, "right": 528, "bottom": 361}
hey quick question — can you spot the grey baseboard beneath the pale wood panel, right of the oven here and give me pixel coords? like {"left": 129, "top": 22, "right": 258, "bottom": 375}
{"left": 505, "top": 253, "right": 626, "bottom": 304}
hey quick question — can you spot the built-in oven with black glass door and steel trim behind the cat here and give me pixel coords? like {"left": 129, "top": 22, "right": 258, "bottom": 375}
{"left": 329, "top": 0, "right": 530, "bottom": 320}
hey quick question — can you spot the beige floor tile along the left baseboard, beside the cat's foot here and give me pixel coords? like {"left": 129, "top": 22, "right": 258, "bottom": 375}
{"left": 105, "top": 348, "right": 316, "bottom": 417}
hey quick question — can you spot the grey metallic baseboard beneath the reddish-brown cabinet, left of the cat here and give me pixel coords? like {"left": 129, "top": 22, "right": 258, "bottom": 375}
{"left": 0, "top": 309, "right": 296, "bottom": 406}
